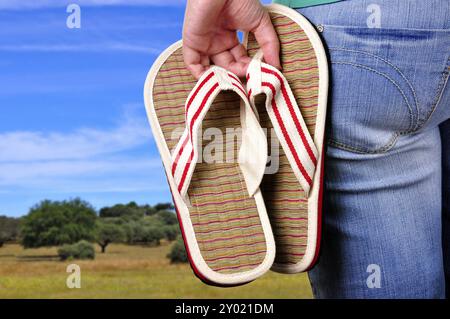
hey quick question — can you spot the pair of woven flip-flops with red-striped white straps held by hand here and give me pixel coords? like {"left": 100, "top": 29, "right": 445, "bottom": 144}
{"left": 144, "top": 5, "right": 328, "bottom": 286}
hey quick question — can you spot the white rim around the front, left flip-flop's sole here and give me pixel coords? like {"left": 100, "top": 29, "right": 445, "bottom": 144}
{"left": 144, "top": 40, "right": 275, "bottom": 286}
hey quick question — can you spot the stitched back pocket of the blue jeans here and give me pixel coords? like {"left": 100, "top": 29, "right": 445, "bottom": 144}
{"left": 323, "top": 25, "right": 444, "bottom": 154}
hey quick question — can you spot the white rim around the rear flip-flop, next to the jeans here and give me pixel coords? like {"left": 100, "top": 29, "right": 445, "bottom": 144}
{"left": 244, "top": 4, "right": 329, "bottom": 274}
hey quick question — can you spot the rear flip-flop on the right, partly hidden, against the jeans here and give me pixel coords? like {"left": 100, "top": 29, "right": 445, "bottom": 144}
{"left": 244, "top": 5, "right": 328, "bottom": 273}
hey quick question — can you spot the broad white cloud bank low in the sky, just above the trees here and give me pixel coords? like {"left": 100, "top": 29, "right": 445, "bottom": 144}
{"left": 0, "top": 106, "right": 165, "bottom": 194}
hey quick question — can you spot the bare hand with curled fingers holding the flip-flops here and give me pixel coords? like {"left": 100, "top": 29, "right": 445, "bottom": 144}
{"left": 183, "top": 0, "right": 281, "bottom": 78}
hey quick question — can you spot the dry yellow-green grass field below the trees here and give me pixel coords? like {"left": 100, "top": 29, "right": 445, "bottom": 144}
{"left": 0, "top": 244, "right": 312, "bottom": 299}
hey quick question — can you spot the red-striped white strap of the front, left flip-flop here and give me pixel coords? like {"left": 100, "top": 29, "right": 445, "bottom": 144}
{"left": 172, "top": 66, "right": 267, "bottom": 203}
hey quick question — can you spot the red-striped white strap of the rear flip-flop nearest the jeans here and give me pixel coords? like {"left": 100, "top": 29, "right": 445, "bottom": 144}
{"left": 247, "top": 53, "right": 318, "bottom": 196}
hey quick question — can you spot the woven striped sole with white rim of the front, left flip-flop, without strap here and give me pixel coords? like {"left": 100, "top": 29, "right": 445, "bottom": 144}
{"left": 144, "top": 41, "right": 275, "bottom": 286}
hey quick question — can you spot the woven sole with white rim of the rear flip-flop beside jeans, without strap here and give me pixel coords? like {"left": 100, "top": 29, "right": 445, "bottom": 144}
{"left": 244, "top": 5, "right": 328, "bottom": 273}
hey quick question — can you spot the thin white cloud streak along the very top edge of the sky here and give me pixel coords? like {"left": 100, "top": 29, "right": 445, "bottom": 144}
{"left": 0, "top": 0, "right": 186, "bottom": 10}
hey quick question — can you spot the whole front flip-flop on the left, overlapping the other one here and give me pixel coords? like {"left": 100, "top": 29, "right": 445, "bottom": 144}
{"left": 144, "top": 41, "right": 275, "bottom": 286}
